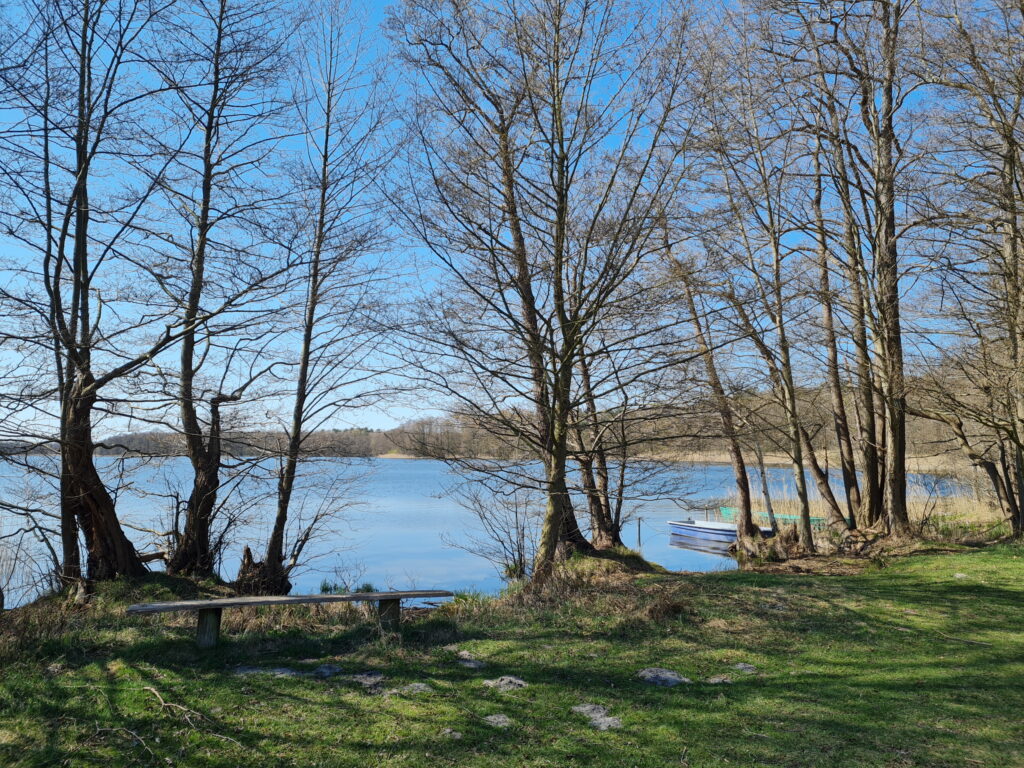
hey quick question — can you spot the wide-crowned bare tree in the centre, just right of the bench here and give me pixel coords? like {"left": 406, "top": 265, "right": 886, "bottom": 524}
{"left": 389, "top": 0, "right": 687, "bottom": 580}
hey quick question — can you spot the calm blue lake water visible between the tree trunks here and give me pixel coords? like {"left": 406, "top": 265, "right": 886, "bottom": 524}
{"left": 3, "top": 457, "right": 950, "bottom": 597}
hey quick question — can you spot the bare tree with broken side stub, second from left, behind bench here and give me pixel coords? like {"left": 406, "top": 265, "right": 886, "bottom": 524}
{"left": 146, "top": 0, "right": 295, "bottom": 575}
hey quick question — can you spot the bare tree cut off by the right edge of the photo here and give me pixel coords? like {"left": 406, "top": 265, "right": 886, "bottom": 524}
{"left": 913, "top": 0, "right": 1024, "bottom": 537}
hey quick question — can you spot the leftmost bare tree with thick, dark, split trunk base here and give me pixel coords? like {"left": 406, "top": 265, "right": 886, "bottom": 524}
{"left": 0, "top": 0, "right": 215, "bottom": 580}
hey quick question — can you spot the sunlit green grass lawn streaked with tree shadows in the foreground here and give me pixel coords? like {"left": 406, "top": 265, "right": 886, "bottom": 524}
{"left": 0, "top": 547, "right": 1024, "bottom": 768}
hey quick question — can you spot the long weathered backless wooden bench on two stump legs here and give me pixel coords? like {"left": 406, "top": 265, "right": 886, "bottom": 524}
{"left": 128, "top": 590, "right": 455, "bottom": 648}
